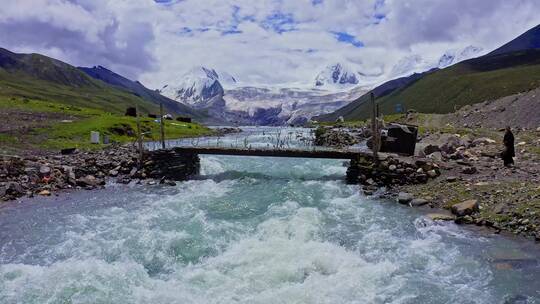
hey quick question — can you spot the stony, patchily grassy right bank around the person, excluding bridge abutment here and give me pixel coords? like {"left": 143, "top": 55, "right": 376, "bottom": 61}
{"left": 394, "top": 130, "right": 540, "bottom": 241}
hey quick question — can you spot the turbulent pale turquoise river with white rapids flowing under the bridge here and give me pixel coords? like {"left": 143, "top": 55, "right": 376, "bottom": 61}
{"left": 0, "top": 129, "right": 540, "bottom": 304}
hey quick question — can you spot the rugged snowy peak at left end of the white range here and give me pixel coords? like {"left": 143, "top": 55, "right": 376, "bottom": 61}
{"left": 161, "top": 66, "right": 236, "bottom": 108}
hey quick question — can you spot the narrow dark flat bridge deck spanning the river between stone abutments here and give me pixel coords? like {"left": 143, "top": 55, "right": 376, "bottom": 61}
{"left": 173, "top": 147, "right": 371, "bottom": 159}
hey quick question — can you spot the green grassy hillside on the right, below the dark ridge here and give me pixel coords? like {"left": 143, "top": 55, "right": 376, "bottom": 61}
{"left": 332, "top": 50, "right": 540, "bottom": 120}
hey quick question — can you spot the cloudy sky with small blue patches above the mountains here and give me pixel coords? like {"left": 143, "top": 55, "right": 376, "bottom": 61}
{"left": 0, "top": 0, "right": 540, "bottom": 88}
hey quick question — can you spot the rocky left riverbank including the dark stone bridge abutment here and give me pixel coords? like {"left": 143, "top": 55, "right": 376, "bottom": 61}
{"left": 0, "top": 145, "right": 199, "bottom": 201}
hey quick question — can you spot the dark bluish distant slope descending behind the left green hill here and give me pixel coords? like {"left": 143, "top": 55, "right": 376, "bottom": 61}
{"left": 79, "top": 66, "right": 208, "bottom": 120}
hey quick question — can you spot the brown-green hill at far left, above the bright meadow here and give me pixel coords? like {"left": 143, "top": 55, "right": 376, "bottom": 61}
{"left": 0, "top": 48, "right": 162, "bottom": 113}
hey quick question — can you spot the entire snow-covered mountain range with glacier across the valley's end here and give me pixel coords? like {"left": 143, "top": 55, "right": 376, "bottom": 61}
{"left": 162, "top": 46, "right": 482, "bottom": 125}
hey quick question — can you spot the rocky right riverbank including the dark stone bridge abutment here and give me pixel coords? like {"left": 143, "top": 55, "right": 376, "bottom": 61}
{"left": 334, "top": 121, "right": 540, "bottom": 241}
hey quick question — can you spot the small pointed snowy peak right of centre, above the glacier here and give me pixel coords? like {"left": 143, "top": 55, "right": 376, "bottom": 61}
{"left": 315, "top": 63, "right": 360, "bottom": 88}
